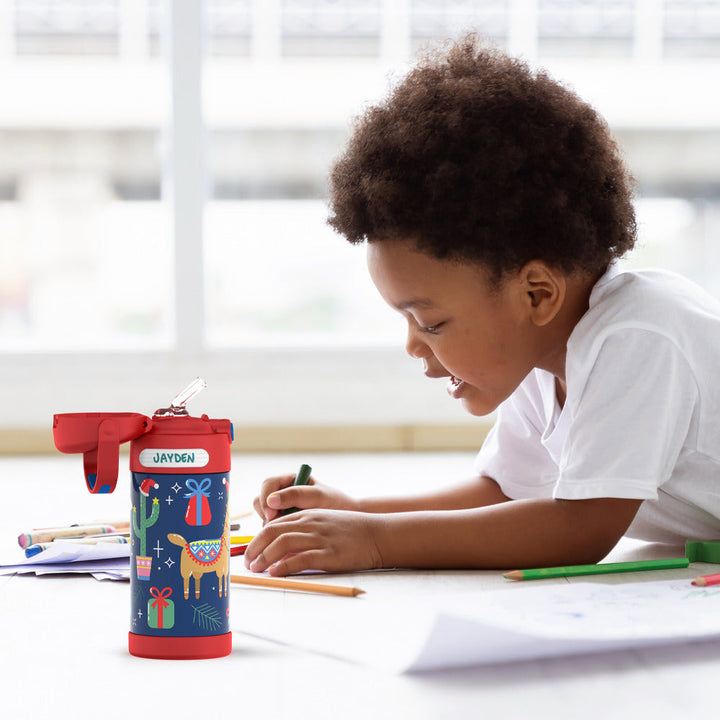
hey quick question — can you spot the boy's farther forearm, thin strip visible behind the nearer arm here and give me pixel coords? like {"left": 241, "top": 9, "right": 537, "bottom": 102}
{"left": 357, "top": 477, "right": 510, "bottom": 513}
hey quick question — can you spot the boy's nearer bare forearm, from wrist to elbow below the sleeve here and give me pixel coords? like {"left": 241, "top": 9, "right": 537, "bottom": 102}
{"left": 375, "top": 498, "right": 641, "bottom": 569}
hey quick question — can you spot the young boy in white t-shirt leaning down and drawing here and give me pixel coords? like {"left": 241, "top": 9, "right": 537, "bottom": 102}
{"left": 246, "top": 36, "right": 720, "bottom": 575}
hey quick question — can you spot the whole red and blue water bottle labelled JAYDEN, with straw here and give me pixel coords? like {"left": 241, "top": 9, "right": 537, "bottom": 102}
{"left": 53, "top": 378, "right": 233, "bottom": 659}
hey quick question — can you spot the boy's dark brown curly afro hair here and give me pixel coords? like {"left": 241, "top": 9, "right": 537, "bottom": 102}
{"left": 328, "top": 34, "right": 636, "bottom": 281}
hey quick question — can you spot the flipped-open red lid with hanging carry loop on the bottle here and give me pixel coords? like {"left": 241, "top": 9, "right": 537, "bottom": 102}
{"left": 53, "top": 413, "right": 152, "bottom": 494}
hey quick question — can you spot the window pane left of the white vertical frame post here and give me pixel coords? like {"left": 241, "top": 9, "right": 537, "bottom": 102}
{"left": 0, "top": 0, "right": 173, "bottom": 351}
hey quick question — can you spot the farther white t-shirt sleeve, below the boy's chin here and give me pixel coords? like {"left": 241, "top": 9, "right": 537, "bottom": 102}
{"left": 474, "top": 373, "right": 558, "bottom": 500}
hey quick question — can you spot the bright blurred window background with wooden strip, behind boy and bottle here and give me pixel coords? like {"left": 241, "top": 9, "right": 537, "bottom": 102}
{"left": 0, "top": 0, "right": 720, "bottom": 452}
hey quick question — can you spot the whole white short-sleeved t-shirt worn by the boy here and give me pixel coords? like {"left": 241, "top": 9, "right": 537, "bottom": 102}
{"left": 475, "top": 266, "right": 720, "bottom": 542}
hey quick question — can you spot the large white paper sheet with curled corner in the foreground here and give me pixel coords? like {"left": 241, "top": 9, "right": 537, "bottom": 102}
{"left": 231, "top": 580, "right": 720, "bottom": 672}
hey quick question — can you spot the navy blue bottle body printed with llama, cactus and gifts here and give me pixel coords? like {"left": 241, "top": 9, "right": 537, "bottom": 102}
{"left": 130, "top": 472, "right": 230, "bottom": 638}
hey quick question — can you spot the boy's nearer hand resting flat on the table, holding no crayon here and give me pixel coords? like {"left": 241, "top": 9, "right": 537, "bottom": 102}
{"left": 245, "top": 509, "right": 382, "bottom": 576}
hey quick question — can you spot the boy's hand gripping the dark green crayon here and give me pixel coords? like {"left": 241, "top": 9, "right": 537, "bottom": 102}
{"left": 253, "top": 474, "right": 358, "bottom": 525}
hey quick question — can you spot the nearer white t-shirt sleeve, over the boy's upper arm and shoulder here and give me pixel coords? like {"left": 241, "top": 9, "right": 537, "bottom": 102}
{"left": 554, "top": 328, "right": 698, "bottom": 500}
